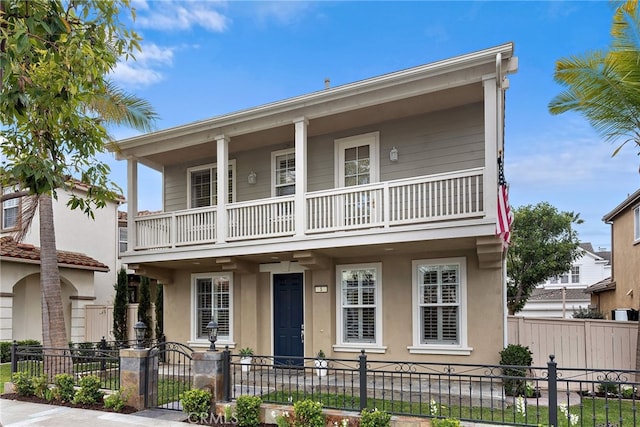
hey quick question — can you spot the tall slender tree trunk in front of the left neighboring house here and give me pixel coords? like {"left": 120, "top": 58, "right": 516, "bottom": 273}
{"left": 38, "top": 195, "right": 71, "bottom": 377}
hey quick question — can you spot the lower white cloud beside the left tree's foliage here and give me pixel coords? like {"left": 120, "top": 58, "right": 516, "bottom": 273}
{"left": 111, "top": 43, "right": 173, "bottom": 87}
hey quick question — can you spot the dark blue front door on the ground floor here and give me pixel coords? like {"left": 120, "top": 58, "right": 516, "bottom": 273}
{"left": 273, "top": 273, "right": 304, "bottom": 366}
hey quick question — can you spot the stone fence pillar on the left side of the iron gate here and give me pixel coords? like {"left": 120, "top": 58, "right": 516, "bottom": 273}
{"left": 120, "top": 348, "right": 158, "bottom": 410}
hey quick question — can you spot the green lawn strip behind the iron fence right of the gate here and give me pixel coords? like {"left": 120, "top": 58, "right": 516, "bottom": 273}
{"left": 262, "top": 390, "right": 640, "bottom": 427}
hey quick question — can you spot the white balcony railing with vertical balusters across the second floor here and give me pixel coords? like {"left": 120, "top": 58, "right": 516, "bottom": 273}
{"left": 135, "top": 168, "right": 484, "bottom": 250}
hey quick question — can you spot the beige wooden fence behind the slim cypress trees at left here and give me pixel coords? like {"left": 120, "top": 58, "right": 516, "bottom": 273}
{"left": 84, "top": 303, "right": 156, "bottom": 342}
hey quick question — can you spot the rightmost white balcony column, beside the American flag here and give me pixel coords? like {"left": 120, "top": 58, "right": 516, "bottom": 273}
{"left": 482, "top": 74, "right": 503, "bottom": 218}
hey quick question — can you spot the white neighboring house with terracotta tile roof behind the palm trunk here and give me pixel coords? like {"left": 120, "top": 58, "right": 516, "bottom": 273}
{"left": 0, "top": 184, "right": 123, "bottom": 342}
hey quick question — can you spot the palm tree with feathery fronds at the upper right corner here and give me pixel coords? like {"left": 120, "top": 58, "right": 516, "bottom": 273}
{"left": 549, "top": 0, "right": 640, "bottom": 381}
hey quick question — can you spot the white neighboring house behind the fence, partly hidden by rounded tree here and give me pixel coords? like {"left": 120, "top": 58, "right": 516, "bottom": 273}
{"left": 518, "top": 243, "right": 611, "bottom": 318}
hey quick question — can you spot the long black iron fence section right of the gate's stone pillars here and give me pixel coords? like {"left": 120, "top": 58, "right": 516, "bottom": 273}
{"left": 223, "top": 351, "right": 640, "bottom": 427}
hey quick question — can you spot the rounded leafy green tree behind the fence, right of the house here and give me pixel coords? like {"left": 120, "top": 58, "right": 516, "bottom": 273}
{"left": 507, "top": 202, "right": 582, "bottom": 314}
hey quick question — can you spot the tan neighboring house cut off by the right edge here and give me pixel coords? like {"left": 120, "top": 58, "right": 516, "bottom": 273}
{"left": 587, "top": 189, "right": 640, "bottom": 320}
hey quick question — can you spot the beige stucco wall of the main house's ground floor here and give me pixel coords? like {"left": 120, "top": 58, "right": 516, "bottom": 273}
{"left": 164, "top": 251, "right": 504, "bottom": 363}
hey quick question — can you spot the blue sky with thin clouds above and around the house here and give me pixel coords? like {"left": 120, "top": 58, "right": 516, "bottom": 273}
{"left": 105, "top": 0, "right": 640, "bottom": 249}
